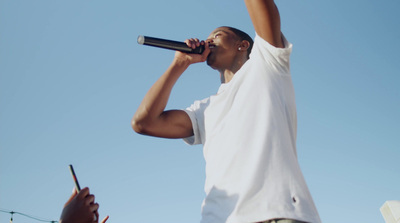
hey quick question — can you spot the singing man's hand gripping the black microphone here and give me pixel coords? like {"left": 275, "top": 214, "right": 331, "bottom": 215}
{"left": 175, "top": 38, "right": 210, "bottom": 65}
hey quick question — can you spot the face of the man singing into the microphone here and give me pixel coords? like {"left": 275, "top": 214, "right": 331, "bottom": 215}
{"left": 206, "top": 27, "right": 240, "bottom": 70}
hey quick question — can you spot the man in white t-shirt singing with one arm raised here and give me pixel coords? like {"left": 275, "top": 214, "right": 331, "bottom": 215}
{"left": 132, "top": 0, "right": 320, "bottom": 223}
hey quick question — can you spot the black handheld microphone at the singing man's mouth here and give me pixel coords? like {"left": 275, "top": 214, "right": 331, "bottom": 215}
{"left": 138, "top": 36, "right": 204, "bottom": 54}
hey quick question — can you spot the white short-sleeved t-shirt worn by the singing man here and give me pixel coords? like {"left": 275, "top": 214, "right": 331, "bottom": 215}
{"left": 184, "top": 35, "right": 321, "bottom": 223}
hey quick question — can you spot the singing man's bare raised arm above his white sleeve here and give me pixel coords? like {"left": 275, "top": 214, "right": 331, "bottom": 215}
{"left": 245, "top": 0, "right": 284, "bottom": 48}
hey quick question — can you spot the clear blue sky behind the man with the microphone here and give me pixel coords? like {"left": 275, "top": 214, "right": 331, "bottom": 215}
{"left": 0, "top": 0, "right": 400, "bottom": 223}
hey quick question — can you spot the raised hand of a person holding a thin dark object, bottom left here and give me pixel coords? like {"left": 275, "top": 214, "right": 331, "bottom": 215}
{"left": 60, "top": 187, "right": 104, "bottom": 223}
